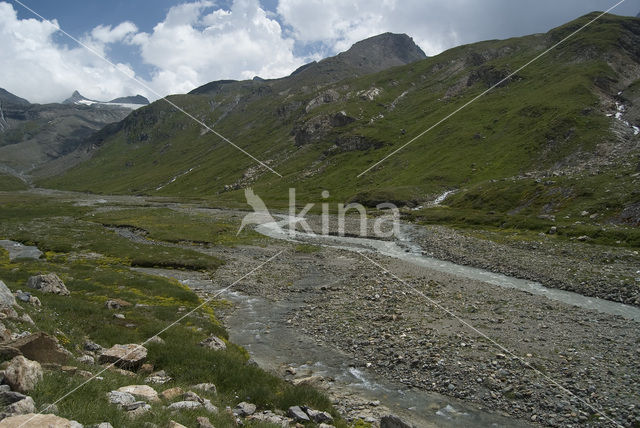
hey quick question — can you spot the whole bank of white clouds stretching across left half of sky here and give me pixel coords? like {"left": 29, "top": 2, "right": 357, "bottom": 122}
{"left": 0, "top": 0, "right": 306, "bottom": 102}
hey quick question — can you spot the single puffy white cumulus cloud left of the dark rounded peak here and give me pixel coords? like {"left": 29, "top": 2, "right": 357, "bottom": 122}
{"left": 132, "top": 0, "right": 304, "bottom": 92}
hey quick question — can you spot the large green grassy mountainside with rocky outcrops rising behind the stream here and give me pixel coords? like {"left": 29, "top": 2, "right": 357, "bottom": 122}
{"left": 40, "top": 14, "right": 640, "bottom": 228}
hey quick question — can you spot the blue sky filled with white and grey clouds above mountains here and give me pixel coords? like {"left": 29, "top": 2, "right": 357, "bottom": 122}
{"left": 0, "top": 0, "right": 640, "bottom": 103}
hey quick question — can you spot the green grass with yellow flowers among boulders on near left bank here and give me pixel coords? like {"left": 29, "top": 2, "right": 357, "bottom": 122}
{"left": 0, "top": 194, "right": 346, "bottom": 427}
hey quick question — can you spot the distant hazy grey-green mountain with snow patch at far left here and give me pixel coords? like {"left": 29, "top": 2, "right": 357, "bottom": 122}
{"left": 0, "top": 89, "right": 136, "bottom": 181}
